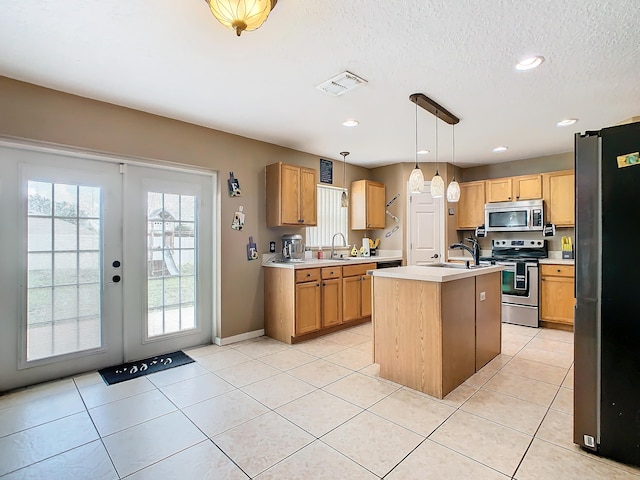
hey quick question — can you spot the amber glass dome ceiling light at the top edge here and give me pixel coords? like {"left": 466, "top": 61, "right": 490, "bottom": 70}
{"left": 205, "top": 0, "right": 278, "bottom": 37}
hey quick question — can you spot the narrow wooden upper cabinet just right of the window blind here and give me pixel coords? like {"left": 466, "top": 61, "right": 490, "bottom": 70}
{"left": 349, "top": 180, "right": 386, "bottom": 230}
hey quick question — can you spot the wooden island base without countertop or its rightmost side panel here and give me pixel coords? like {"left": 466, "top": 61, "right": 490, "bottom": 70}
{"left": 373, "top": 277, "right": 475, "bottom": 398}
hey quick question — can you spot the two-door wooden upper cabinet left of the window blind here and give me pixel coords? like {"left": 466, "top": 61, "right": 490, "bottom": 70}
{"left": 266, "top": 162, "right": 318, "bottom": 227}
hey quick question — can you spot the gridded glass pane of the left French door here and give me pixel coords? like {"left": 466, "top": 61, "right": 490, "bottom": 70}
{"left": 27, "top": 181, "right": 102, "bottom": 361}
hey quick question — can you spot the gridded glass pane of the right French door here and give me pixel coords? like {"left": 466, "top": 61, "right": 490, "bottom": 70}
{"left": 147, "top": 192, "right": 197, "bottom": 337}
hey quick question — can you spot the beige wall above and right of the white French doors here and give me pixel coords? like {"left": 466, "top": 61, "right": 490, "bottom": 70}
{"left": 0, "top": 77, "right": 370, "bottom": 338}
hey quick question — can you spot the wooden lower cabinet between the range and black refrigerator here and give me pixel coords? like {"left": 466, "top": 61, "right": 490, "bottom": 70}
{"left": 540, "top": 264, "right": 576, "bottom": 326}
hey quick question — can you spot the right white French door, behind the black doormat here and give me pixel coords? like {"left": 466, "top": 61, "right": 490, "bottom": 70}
{"left": 124, "top": 165, "right": 215, "bottom": 361}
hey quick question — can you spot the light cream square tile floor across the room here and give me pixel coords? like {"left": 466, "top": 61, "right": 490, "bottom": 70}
{"left": 0, "top": 324, "right": 640, "bottom": 480}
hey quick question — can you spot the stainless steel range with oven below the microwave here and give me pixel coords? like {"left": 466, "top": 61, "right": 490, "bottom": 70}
{"left": 480, "top": 240, "right": 548, "bottom": 327}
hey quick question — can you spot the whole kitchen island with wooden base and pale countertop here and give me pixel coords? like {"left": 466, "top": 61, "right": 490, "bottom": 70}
{"left": 372, "top": 264, "right": 503, "bottom": 398}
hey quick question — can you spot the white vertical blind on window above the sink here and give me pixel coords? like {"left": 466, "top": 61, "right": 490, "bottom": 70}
{"left": 306, "top": 185, "right": 349, "bottom": 247}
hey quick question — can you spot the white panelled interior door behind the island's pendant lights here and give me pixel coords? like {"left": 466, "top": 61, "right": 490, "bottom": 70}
{"left": 407, "top": 182, "right": 443, "bottom": 265}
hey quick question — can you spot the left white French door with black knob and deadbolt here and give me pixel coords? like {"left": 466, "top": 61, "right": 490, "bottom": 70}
{"left": 0, "top": 145, "right": 123, "bottom": 390}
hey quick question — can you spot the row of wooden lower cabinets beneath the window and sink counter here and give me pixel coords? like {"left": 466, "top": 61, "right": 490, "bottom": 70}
{"left": 264, "top": 263, "right": 376, "bottom": 343}
